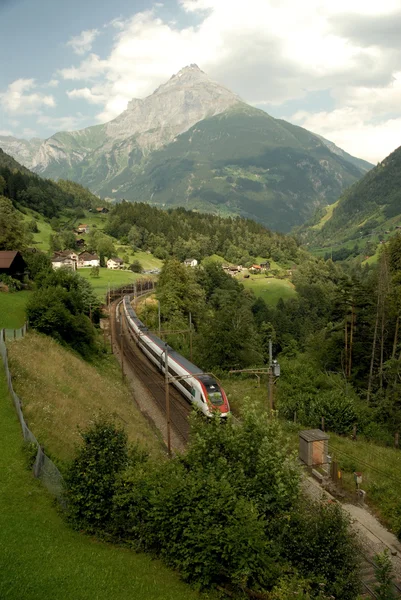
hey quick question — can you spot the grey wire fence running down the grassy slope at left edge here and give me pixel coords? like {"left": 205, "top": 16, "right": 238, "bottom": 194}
{"left": 0, "top": 323, "right": 63, "bottom": 500}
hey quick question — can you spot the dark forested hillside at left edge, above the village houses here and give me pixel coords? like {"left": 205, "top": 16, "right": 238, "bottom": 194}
{"left": 0, "top": 148, "right": 99, "bottom": 218}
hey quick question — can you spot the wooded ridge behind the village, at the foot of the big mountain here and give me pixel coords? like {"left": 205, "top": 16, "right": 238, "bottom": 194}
{"left": 105, "top": 202, "right": 299, "bottom": 265}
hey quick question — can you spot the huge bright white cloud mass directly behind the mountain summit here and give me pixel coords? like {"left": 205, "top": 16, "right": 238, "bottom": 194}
{"left": 52, "top": 0, "right": 401, "bottom": 159}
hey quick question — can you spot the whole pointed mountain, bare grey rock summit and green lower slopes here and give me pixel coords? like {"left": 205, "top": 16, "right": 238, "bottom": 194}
{"left": 0, "top": 65, "right": 369, "bottom": 231}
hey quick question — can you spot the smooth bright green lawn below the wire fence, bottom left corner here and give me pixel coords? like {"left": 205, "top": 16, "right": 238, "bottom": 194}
{"left": 0, "top": 365, "right": 212, "bottom": 600}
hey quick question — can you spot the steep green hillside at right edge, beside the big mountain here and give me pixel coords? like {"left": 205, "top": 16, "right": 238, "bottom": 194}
{"left": 300, "top": 148, "right": 401, "bottom": 256}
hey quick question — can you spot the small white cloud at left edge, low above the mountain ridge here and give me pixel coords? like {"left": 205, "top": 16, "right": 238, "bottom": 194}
{"left": 0, "top": 79, "right": 56, "bottom": 115}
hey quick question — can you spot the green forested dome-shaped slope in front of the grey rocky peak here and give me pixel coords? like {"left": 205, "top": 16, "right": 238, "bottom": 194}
{"left": 100, "top": 104, "right": 363, "bottom": 231}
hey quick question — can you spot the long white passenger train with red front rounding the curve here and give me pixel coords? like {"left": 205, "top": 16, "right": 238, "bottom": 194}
{"left": 123, "top": 296, "right": 230, "bottom": 418}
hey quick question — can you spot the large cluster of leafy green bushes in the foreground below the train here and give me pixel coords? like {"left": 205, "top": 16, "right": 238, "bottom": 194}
{"left": 66, "top": 407, "right": 357, "bottom": 600}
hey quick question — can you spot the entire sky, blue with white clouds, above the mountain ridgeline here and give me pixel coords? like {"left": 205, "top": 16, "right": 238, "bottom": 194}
{"left": 0, "top": 0, "right": 401, "bottom": 163}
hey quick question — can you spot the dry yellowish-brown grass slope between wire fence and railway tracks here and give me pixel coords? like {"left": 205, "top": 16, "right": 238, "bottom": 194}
{"left": 9, "top": 332, "right": 162, "bottom": 461}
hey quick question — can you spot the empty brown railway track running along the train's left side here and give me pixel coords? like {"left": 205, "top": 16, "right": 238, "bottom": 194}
{"left": 112, "top": 302, "right": 191, "bottom": 444}
